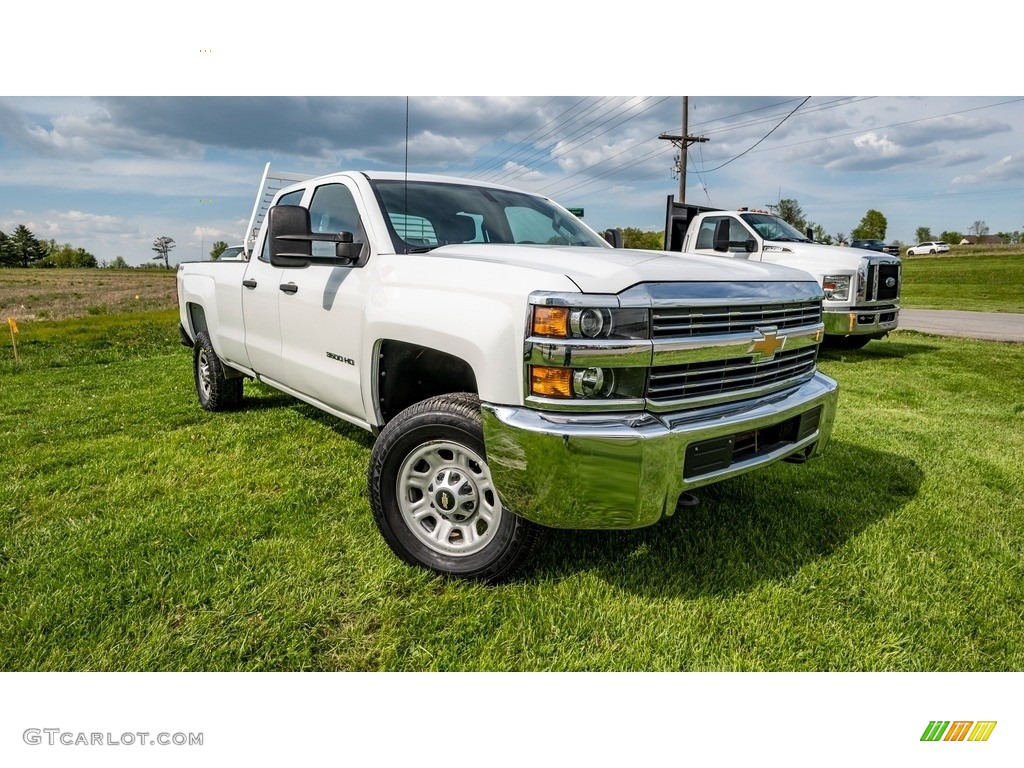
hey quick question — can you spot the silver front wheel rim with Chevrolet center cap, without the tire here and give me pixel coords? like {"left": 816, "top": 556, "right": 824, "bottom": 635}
{"left": 395, "top": 440, "right": 502, "bottom": 556}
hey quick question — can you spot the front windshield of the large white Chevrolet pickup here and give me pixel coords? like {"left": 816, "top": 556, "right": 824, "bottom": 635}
{"left": 371, "top": 179, "right": 607, "bottom": 253}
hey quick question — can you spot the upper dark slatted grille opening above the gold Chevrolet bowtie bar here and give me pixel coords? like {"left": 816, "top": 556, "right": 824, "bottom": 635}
{"left": 651, "top": 301, "right": 821, "bottom": 339}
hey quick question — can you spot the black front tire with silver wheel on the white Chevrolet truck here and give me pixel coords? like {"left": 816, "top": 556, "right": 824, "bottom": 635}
{"left": 368, "top": 392, "right": 542, "bottom": 583}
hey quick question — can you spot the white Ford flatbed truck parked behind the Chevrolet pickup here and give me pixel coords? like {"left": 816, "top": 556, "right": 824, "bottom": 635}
{"left": 665, "top": 201, "right": 902, "bottom": 349}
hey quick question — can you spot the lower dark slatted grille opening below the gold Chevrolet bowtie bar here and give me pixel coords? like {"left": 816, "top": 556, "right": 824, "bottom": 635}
{"left": 647, "top": 345, "right": 817, "bottom": 403}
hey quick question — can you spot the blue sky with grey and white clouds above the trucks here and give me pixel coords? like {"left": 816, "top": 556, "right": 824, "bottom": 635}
{"left": 0, "top": 95, "right": 1024, "bottom": 264}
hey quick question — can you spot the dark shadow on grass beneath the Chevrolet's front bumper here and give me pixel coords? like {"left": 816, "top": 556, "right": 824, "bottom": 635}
{"left": 526, "top": 440, "right": 924, "bottom": 597}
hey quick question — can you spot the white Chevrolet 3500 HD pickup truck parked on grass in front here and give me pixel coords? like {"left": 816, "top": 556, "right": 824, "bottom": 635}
{"left": 177, "top": 165, "right": 838, "bottom": 582}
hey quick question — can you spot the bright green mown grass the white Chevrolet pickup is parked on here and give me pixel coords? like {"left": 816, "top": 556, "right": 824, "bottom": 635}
{"left": 0, "top": 270, "right": 1024, "bottom": 671}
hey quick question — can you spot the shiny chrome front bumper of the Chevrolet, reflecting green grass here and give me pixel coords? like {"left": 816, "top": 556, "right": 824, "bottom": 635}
{"left": 481, "top": 373, "right": 839, "bottom": 528}
